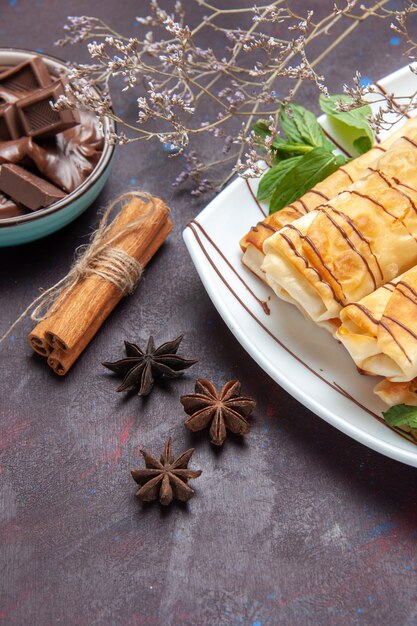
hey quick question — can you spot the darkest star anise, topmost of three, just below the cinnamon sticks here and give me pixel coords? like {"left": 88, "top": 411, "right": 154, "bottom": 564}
{"left": 103, "top": 335, "right": 197, "bottom": 396}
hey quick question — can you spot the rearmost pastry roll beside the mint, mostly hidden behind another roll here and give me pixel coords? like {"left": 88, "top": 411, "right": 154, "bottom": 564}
{"left": 240, "top": 118, "right": 417, "bottom": 280}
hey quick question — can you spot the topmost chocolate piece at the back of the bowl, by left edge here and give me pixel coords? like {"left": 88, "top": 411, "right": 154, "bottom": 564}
{"left": 0, "top": 57, "right": 52, "bottom": 100}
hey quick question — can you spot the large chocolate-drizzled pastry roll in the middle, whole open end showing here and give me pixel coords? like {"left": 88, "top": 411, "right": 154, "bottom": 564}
{"left": 262, "top": 128, "right": 417, "bottom": 323}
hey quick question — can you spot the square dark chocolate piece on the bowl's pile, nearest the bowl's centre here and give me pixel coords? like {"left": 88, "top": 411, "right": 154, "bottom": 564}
{"left": 16, "top": 80, "right": 79, "bottom": 137}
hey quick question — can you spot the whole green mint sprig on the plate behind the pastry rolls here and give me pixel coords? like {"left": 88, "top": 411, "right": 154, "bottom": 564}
{"left": 253, "top": 95, "right": 374, "bottom": 213}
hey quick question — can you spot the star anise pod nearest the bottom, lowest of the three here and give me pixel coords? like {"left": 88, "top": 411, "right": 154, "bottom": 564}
{"left": 131, "top": 437, "right": 201, "bottom": 505}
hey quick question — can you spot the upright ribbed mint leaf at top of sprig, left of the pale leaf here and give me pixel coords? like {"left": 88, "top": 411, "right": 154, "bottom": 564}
{"left": 279, "top": 103, "right": 334, "bottom": 150}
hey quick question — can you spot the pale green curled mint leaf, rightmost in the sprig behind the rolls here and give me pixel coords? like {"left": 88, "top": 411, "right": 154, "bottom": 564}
{"left": 319, "top": 94, "right": 374, "bottom": 154}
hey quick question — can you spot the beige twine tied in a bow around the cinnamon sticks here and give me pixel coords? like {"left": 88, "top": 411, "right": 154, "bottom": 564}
{"left": 0, "top": 191, "right": 154, "bottom": 343}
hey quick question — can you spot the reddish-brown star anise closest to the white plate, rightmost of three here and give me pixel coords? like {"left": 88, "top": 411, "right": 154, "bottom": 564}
{"left": 180, "top": 380, "right": 256, "bottom": 446}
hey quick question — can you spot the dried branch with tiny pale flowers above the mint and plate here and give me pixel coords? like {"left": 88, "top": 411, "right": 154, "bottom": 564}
{"left": 57, "top": 0, "right": 402, "bottom": 195}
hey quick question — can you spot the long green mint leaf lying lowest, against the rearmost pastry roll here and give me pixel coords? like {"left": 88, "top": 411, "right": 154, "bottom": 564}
{"left": 269, "top": 148, "right": 346, "bottom": 213}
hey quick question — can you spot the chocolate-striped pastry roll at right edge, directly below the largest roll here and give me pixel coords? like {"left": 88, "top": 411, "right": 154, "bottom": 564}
{"left": 336, "top": 266, "right": 417, "bottom": 382}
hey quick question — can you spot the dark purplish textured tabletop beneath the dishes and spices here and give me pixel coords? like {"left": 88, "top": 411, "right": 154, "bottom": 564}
{"left": 0, "top": 0, "right": 417, "bottom": 626}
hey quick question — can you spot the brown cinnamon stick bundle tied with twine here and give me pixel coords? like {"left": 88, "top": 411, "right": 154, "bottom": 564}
{"left": 28, "top": 197, "right": 172, "bottom": 376}
